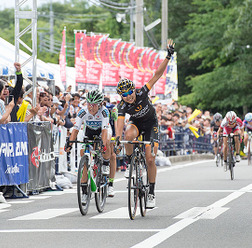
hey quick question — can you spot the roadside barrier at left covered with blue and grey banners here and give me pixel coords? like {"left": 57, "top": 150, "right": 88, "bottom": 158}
{"left": 0, "top": 122, "right": 55, "bottom": 197}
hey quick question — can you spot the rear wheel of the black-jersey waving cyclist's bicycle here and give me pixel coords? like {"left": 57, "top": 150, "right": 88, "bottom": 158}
{"left": 139, "top": 153, "right": 149, "bottom": 217}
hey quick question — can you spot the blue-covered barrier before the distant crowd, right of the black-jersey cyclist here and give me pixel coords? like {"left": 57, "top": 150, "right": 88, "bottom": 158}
{"left": 159, "top": 127, "right": 213, "bottom": 156}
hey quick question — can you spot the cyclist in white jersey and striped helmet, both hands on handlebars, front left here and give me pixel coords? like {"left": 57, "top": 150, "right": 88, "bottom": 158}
{"left": 65, "top": 89, "right": 112, "bottom": 204}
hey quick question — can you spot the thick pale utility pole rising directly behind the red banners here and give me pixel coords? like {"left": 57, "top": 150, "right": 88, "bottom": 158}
{"left": 135, "top": 0, "right": 144, "bottom": 47}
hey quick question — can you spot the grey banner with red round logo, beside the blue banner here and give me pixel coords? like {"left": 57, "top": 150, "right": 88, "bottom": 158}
{"left": 27, "top": 122, "right": 55, "bottom": 192}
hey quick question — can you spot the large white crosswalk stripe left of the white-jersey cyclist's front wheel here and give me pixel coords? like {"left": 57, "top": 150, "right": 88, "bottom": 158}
{"left": 10, "top": 208, "right": 79, "bottom": 220}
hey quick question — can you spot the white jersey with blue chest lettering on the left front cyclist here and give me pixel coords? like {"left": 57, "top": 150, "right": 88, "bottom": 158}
{"left": 74, "top": 106, "right": 111, "bottom": 132}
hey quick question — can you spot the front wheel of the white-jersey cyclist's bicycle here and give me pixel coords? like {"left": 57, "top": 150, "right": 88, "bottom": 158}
{"left": 77, "top": 156, "right": 91, "bottom": 215}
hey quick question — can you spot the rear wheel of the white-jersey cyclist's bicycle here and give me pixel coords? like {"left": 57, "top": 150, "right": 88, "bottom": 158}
{"left": 95, "top": 159, "right": 108, "bottom": 213}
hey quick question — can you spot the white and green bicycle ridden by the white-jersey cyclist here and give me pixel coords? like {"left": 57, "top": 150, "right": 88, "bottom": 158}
{"left": 69, "top": 137, "right": 108, "bottom": 215}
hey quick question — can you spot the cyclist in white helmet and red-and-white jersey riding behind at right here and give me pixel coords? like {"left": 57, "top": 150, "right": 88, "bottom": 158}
{"left": 217, "top": 111, "right": 244, "bottom": 168}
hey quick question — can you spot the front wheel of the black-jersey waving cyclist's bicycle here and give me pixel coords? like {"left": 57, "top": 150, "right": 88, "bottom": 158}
{"left": 128, "top": 154, "right": 139, "bottom": 220}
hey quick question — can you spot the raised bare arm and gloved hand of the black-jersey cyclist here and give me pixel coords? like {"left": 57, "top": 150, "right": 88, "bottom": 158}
{"left": 148, "top": 40, "right": 175, "bottom": 88}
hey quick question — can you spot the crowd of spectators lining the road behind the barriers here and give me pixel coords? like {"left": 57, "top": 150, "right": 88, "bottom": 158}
{"left": 0, "top": 63, "right": 217, "bottom": 169}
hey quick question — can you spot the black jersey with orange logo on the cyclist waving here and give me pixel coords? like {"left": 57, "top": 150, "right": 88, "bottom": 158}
{"left": 117, "top": 85, "right": 156, "bottom": 122}
